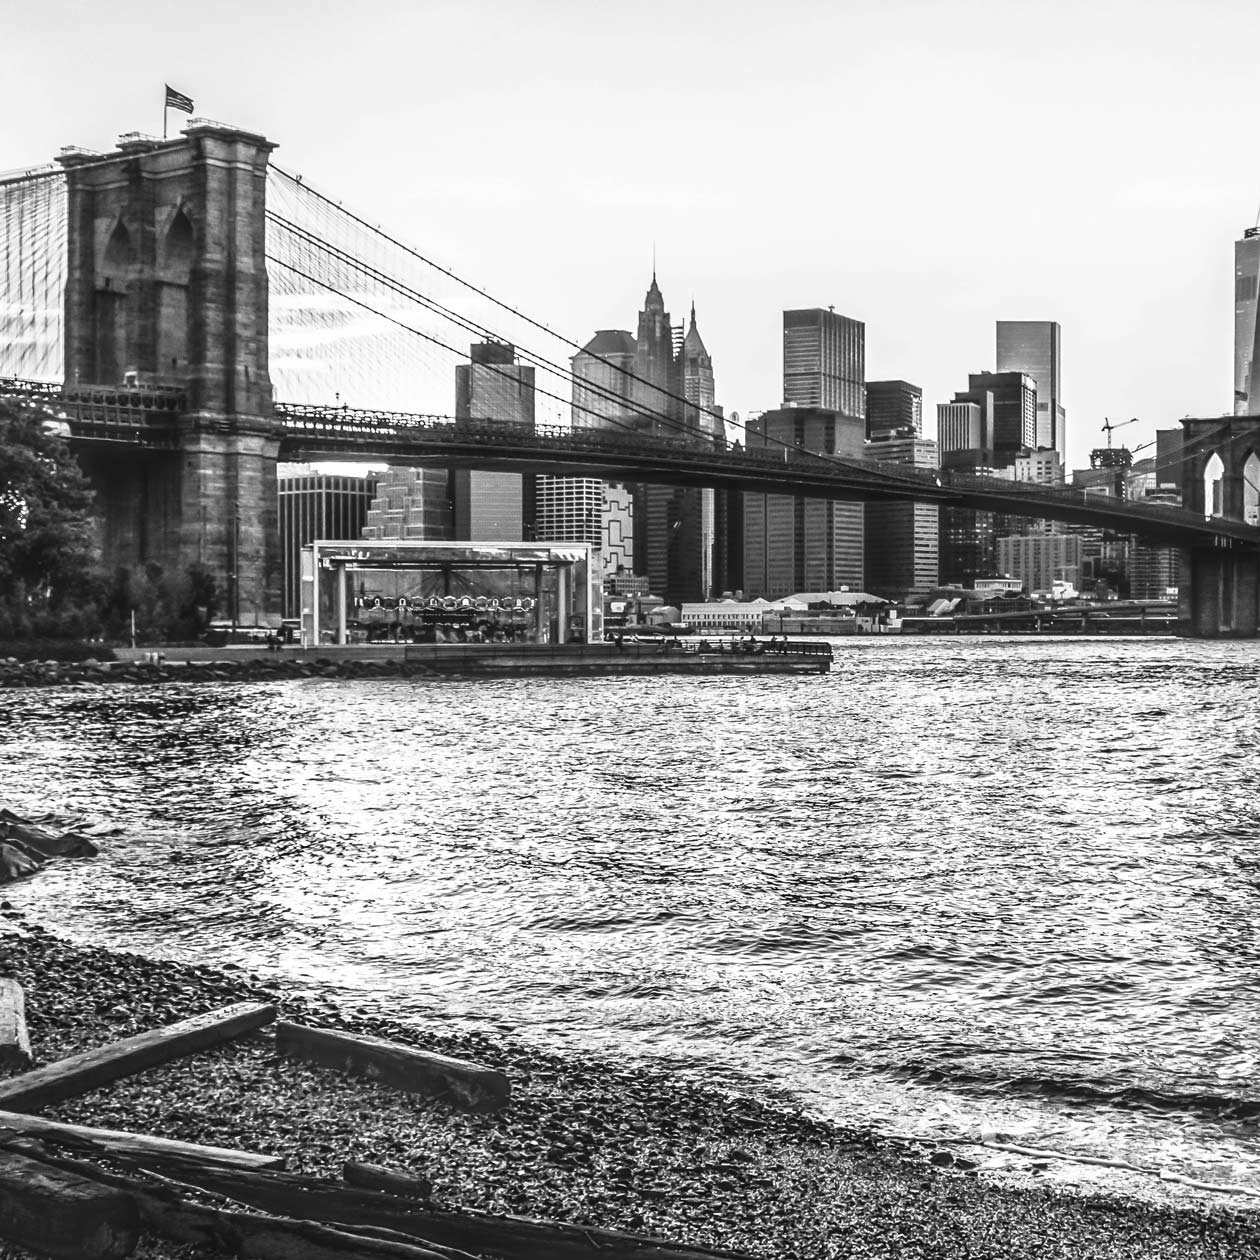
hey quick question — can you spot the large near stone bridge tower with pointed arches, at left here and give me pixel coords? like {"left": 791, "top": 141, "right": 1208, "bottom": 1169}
{"left": 60, "top": 122, "right": 281, "bottom": 624}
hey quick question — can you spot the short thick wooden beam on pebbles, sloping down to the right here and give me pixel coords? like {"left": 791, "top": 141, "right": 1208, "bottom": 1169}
{"left": 276, "top": 1019, "right": 512, "bottom": 1111}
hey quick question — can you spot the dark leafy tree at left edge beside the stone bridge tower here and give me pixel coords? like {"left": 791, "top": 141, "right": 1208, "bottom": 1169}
{"left": 0, "top": 399, "right": 98, "bottom": 638}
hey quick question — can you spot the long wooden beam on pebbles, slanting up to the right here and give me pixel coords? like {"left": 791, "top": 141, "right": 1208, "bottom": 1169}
{"left": 0, "top": 1002, "right": 276, "bottom": 1111}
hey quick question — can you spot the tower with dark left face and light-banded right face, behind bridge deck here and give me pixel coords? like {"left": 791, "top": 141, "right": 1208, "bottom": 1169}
{"left": 864, "top": 438, "right": 940, "bottom": 600}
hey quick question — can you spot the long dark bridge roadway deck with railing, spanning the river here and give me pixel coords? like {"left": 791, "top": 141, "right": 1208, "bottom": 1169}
{"left": 0, "top": 379, "right": 1260, "bottom": 551}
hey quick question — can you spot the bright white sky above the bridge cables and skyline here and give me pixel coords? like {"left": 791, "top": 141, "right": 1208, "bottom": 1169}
{"left": 0, "top": 0, "right": 1260, "bottom": 466}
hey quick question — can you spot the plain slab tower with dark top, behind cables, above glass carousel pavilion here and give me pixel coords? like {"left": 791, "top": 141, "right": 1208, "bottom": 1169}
{"left": 452, "top": 341, "right": 534, "bottom": 543}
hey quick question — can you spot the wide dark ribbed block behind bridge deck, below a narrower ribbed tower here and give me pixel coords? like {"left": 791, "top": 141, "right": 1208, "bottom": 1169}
{"left": 743, "top": 406, "right": 866, "bottom": 600}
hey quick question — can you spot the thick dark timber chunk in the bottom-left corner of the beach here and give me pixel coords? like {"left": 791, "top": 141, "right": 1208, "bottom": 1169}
{"left": 0, "top": 1150, "right": 140, "bottom": 1260}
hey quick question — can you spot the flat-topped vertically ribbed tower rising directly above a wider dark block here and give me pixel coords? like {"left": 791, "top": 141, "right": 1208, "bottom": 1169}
{"left": 784, "top": 307, "right": 866, "bottom": 420}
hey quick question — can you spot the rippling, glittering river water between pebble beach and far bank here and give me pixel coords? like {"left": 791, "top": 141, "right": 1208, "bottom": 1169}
{"left": 0, "top": 638, "right": 1260, "bottom": 1205}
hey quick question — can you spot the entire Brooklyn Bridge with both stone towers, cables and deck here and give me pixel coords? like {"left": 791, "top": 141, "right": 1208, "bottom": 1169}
{"left": 0, "top": 120, "right": 1260, "bottom": 636}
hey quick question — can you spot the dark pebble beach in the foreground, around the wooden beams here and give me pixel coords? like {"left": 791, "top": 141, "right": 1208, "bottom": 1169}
{"left": 0, "top": 902, "right": 1260, "bottom": 1260}
